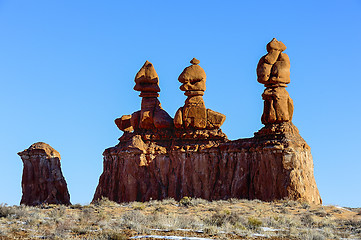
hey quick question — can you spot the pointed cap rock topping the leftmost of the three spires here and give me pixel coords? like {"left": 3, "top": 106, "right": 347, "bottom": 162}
{"left": 134, "top": 61, "right": 160, "bottom": 92}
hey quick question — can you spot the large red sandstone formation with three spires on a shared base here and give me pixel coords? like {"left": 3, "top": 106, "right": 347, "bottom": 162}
{"left": 93, "top": 44, "right": 321, "bottom": 204}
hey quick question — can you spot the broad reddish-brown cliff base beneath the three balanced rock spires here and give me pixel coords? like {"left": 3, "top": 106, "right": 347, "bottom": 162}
{"left": 93, "top": 123, "right": 322, "bottom": 204}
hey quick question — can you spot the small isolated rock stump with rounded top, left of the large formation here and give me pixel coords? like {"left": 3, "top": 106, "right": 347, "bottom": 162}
{"left": 18, "top": 142, "right": 70, "bottom": 206}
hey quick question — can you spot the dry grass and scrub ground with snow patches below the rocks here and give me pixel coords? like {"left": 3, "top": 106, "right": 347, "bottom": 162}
{"left": 0, "top": 198, "right": 361, "bottom": 240}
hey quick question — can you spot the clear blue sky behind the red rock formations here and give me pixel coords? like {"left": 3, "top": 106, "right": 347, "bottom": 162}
{"left": 0, "top": 0, "right": 361, "bottom": 207}
